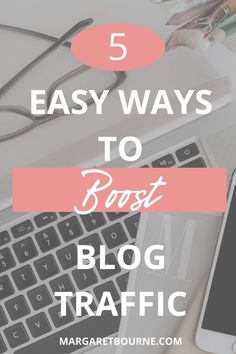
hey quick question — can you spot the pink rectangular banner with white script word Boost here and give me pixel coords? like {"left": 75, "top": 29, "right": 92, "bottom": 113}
{"left": 13, "top": 168, "right": 227, "bottom": 214}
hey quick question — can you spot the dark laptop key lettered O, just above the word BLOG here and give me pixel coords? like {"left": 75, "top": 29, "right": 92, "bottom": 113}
{"left": 102, "top": 224, "right": 128, "bottom": 249}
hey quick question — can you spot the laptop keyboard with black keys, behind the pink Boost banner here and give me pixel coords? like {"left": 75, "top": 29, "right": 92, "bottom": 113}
{"left": 0, "top": 142, "right": 207, "bottom": 354}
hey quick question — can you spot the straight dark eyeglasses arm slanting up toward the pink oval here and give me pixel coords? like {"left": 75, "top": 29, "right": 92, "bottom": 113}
{"left": 0, "top": 18, "right": 93, "bottom": 97}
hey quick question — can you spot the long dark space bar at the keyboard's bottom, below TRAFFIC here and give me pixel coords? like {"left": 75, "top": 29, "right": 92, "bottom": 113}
{"left": 15, "top": 305, "right": 120, "bottom": 354}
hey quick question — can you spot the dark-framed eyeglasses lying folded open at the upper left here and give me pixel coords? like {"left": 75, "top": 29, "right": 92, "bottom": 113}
{"left": 0, "top": 18, "right": 126, "bottom": 142}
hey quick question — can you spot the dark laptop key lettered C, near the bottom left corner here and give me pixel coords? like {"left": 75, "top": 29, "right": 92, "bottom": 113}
{"left": 4, "top": 323, "right": 29, "bottom": 348}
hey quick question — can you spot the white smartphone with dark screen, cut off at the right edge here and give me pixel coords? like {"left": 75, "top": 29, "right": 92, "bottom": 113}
{"left": 196, "top": 171, "right": 236, "bottom": 354}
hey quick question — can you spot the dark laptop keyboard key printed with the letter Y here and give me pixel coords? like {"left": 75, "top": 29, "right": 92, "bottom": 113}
{"left": 34, "top": 255, "right": 59, "bottom": 280}
